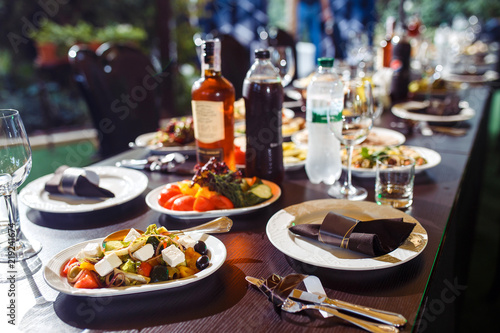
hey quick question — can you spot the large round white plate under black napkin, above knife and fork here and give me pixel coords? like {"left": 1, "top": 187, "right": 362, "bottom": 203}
{"left": 266, "top": 199, "right": 428, "bottom": 271}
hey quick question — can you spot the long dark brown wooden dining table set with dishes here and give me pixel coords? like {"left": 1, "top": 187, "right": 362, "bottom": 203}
{"left": 4, "top": 86, "right": 490, "bottom": 332}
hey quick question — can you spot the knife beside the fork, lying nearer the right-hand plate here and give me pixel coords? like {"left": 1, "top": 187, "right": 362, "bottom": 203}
{"left": 290, "top": 289, "right": 407, "bottom": 327}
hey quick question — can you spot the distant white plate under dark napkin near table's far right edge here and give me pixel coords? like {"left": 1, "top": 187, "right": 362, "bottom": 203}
{"left": 391, "top": 101, "right": 476, "bottom": 123}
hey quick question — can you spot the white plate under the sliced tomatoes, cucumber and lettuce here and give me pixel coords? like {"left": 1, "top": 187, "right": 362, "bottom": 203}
{"left": 146, "top": 180, "right": 281, "bottom": 219}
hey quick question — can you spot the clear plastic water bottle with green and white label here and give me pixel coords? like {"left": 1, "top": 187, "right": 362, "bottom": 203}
{"left": 306, "top": 58, "right": 344, "bottom": 185}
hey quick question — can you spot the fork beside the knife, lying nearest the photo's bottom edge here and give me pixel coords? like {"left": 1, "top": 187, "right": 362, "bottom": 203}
{"left": 281, "top": 298, "right": 399, "bottom": 333}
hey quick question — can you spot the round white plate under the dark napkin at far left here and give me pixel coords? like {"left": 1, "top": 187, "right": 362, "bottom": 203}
{"left": 19, "top": 166, "right": 148, "bottom": 213}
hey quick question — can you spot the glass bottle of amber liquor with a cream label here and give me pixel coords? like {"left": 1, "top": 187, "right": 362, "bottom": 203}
{"left": 191, "top": 39, "right": 236, "bottom": 170}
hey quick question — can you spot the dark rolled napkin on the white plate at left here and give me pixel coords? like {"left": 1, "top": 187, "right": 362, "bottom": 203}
{"left": 45, "top": 165, "right": 115, "bottom": 198}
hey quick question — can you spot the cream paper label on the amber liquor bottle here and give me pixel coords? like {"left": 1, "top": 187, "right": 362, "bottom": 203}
{"left": 191, "top": 101, "right": 224, "bottom": 143}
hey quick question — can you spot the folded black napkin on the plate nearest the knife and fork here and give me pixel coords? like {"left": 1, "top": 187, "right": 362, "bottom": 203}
{"left": 289, "top": 212, "right": 416, "bottom": 257}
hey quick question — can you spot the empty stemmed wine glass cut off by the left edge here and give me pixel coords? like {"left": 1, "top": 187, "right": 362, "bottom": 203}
{"left": 0, "top": 109, "right": 41, "bottom": 265}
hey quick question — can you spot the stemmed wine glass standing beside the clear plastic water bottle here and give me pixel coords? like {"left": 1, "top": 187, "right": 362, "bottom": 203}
{"left": 327, "top": 80, "right": 373, "bottom": 200}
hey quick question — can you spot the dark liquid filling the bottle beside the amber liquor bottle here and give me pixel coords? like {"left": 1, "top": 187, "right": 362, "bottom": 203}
{"left": 243, "top": 82, "right": 285, "bottom": 183}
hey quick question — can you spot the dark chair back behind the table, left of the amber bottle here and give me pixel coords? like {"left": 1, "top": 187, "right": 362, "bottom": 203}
{"left": 68, "top": 44, "right": 161, "bottom": 158}
